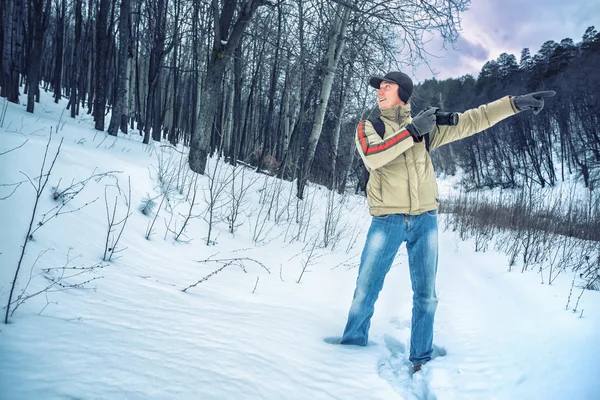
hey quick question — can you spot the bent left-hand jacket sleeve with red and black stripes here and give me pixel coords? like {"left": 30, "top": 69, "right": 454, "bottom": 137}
{"left": 355, "top": 121, "right": 414, "bottom": 170}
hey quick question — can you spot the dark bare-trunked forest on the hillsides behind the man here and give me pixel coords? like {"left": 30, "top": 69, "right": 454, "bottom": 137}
{"left": 0, "top": 0, "right": 600, "bottom": 198}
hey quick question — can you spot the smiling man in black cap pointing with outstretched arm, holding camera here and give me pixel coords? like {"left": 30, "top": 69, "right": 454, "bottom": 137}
{"left": 341, "top": 72, "right": 555, "bottom": 372}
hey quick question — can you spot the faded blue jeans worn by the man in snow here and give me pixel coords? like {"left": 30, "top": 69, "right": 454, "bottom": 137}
{"left": 341, "top": 210, "right": 438, "bottom": 365}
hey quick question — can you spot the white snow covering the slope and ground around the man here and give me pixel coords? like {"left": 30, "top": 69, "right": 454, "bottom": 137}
{"left": 0, "top": 93, "right": 600, "bottom": 400}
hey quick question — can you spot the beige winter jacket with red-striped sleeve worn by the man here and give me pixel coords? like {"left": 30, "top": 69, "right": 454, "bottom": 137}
{"left": 355, "top": 96, "right": 518, "bottom": 216}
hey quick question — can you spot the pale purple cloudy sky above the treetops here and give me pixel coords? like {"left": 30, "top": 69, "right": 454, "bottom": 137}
{"left": 414, "top": 0, "right": 600, "bottom": 82}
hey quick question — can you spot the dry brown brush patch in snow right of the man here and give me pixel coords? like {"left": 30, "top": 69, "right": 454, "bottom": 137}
{"left": 442, "top": 183, "right": 600, "bottom": 289}
